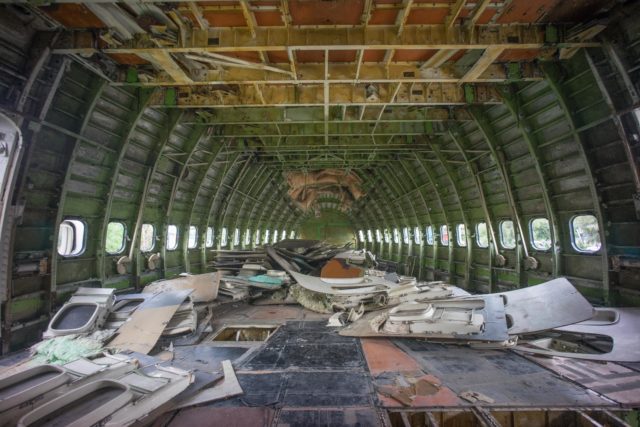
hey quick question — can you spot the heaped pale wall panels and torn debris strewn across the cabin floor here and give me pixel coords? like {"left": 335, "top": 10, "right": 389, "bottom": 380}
{"left": 0, "top": 240, "right": 640, "bottom": 426}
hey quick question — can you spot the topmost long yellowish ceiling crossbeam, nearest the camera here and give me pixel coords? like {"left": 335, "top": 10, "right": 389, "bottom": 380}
{"left": 53, "top": 25, "right": 601, "bottom": 55}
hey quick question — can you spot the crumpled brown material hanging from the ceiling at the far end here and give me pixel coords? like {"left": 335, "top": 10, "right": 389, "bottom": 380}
{"left": 287, "top": 169, "right": 364, "bottom": 211}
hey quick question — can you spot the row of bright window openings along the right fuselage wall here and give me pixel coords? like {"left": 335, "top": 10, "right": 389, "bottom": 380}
{"left": 358, "top": 215, "right": 602, "bottom": 253}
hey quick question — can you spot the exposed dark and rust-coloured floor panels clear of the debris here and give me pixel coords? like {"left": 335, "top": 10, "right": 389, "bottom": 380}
{"left": 154, "top": 303, "right": 640, "bottom": 427}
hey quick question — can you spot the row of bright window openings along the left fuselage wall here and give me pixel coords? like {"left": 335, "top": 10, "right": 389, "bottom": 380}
{"left": 58, "top": 219, "right": 296, "bottom": 257}
